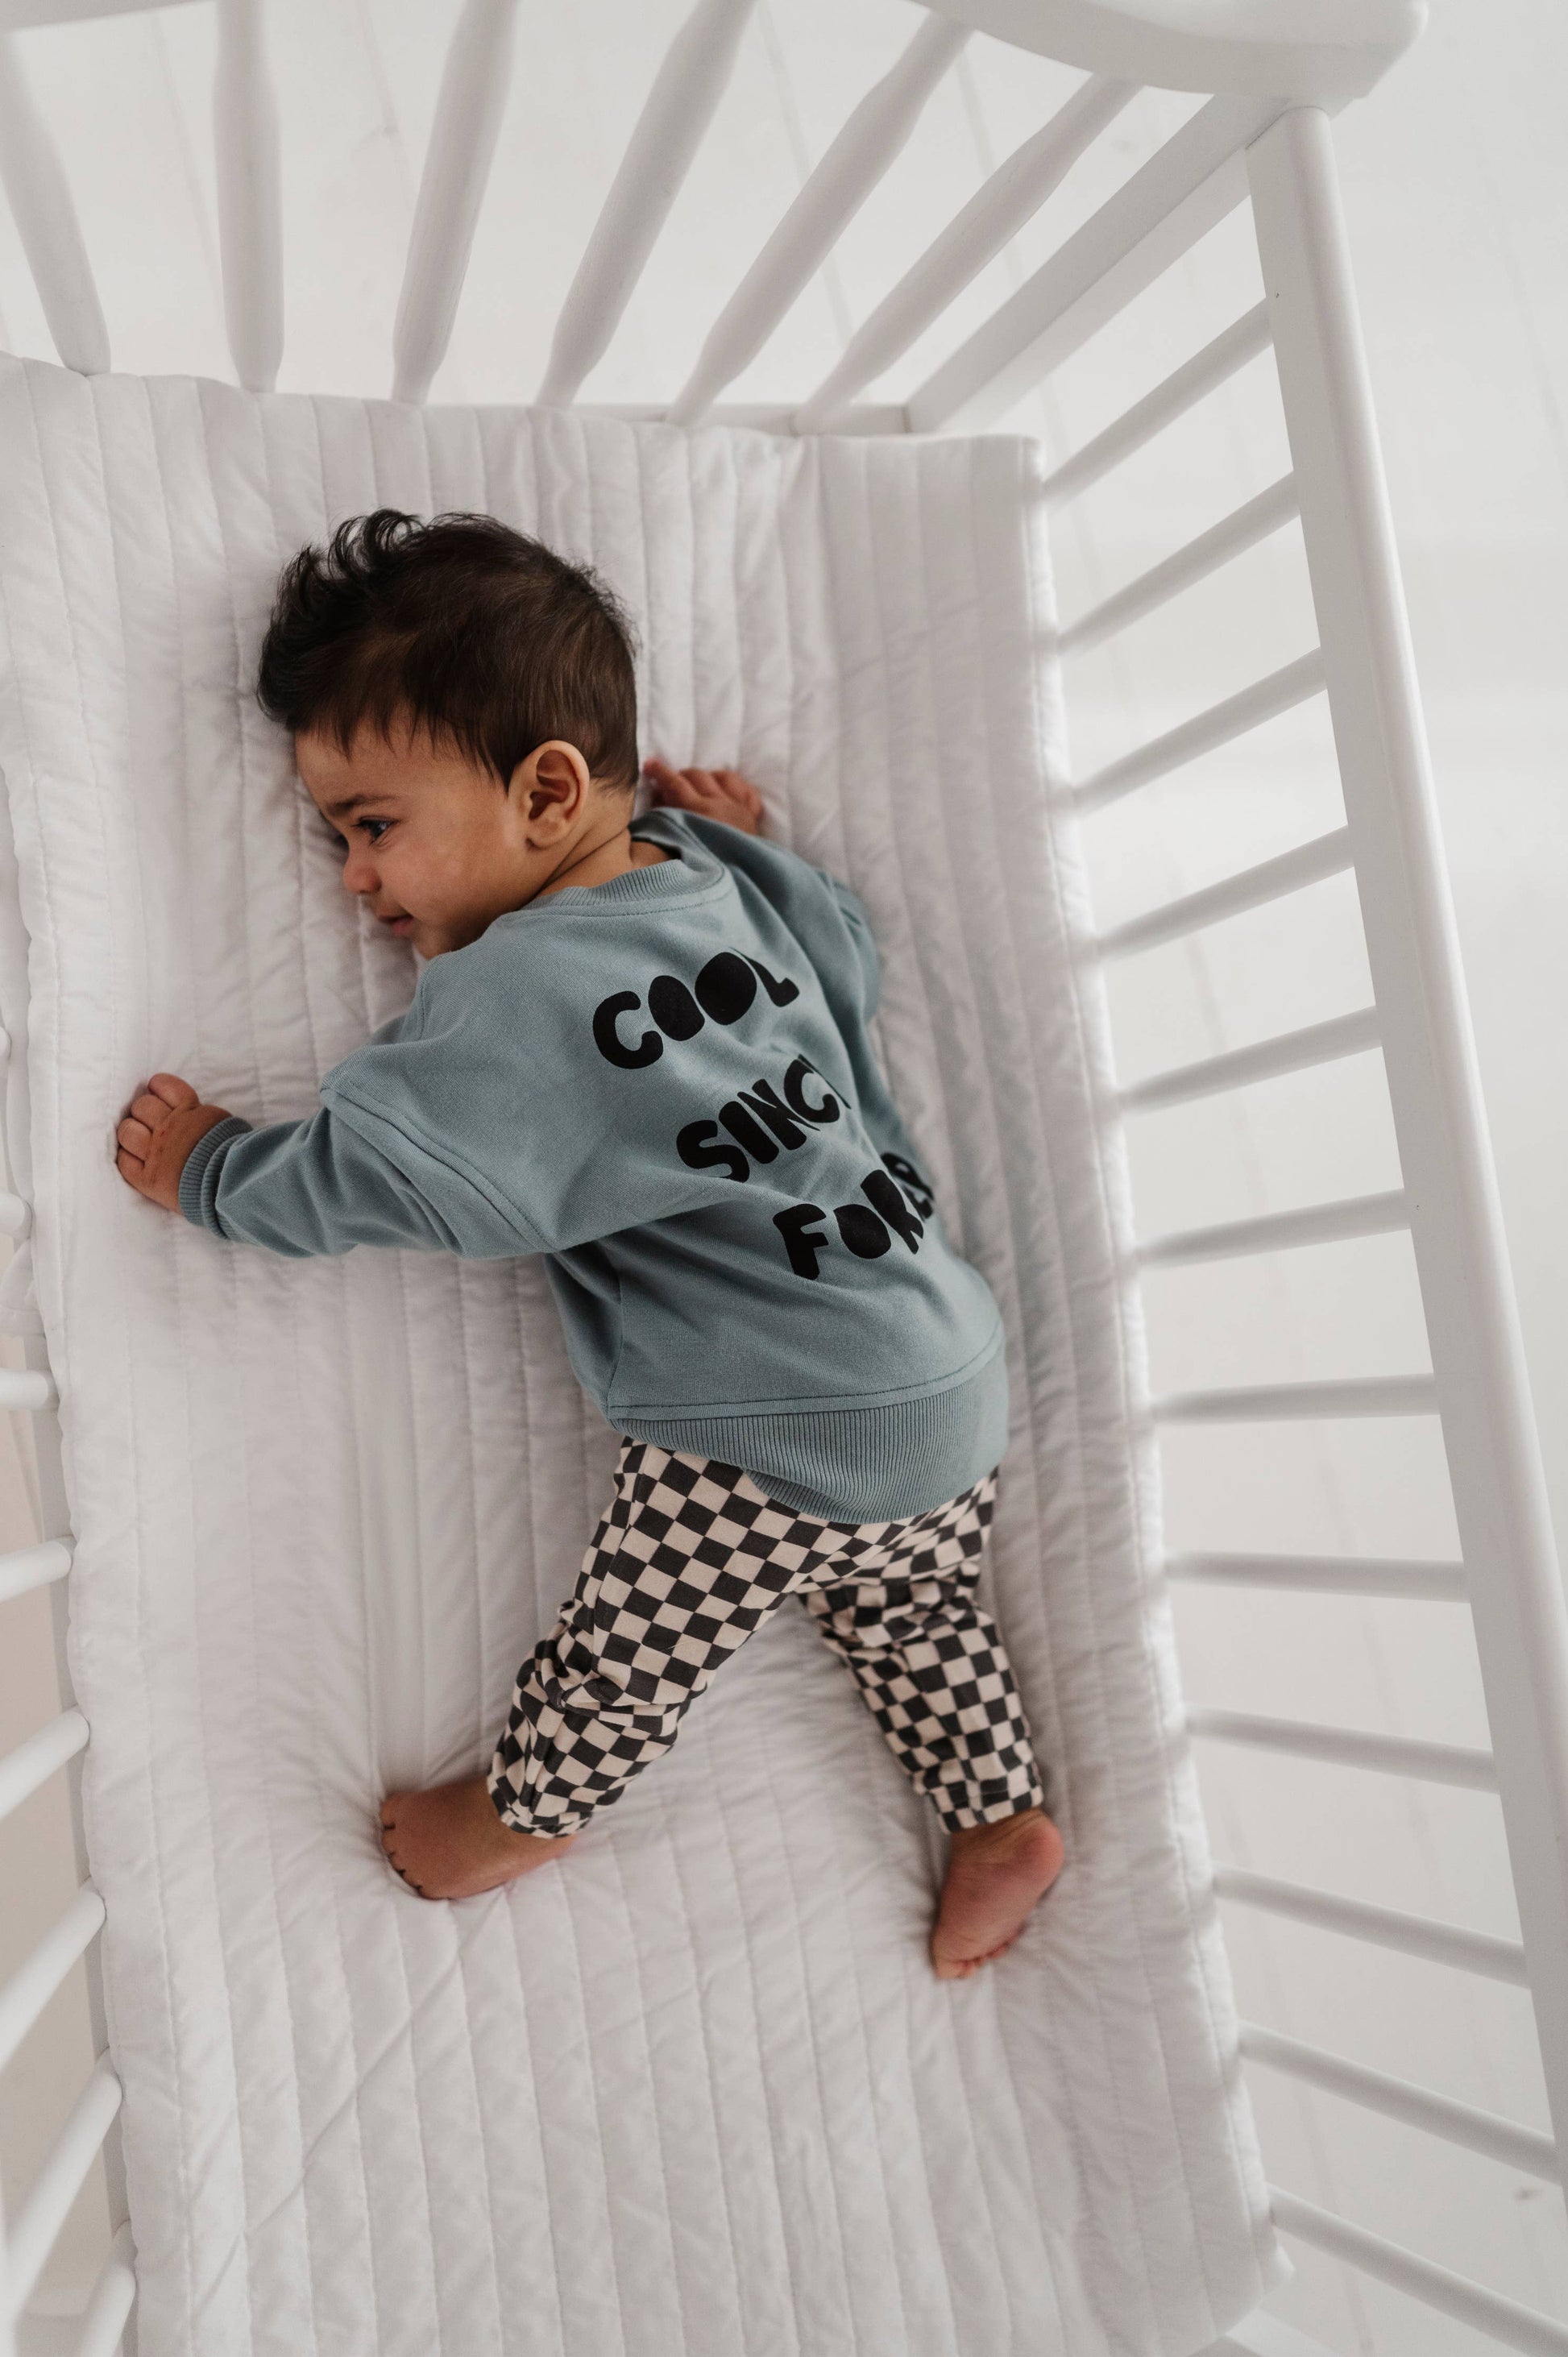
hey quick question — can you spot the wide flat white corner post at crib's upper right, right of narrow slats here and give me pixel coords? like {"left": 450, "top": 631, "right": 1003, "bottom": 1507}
{"left": 911, "top": 97, "right": 1285, "bottom": 434}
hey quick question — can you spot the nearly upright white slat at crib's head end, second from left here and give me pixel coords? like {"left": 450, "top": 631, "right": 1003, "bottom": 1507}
{"left": 212, "top": 0, "right": 283, "bottom": 393}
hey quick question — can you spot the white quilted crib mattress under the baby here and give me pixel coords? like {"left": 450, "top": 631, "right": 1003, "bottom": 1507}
{"left": 0, "top": 361, "right": 1280, "bottom": 2357}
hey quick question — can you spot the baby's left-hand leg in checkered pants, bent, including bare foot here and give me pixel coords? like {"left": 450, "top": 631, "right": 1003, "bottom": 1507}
{"left": 382, "top": 1440, "right": 807, "bottom": 1898}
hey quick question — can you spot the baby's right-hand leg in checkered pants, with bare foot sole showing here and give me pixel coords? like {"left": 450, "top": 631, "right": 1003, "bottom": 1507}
{"left": 804, "top": 1478, "right": 1061, "bottom": 1980}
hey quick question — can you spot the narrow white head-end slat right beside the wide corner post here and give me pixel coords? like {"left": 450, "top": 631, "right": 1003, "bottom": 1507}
{"left": 792, "top": 76, "right": 1139, "bottom": 434}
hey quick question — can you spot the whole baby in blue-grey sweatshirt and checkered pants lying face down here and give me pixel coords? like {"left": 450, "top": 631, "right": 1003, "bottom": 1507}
{"left": 115, "top": 509, "right": 1061, "bottom": 1980}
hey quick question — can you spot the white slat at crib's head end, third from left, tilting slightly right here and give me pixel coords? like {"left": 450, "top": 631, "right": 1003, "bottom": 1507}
{"left": 392, "top": 0, "right": 516, "bottom": 403}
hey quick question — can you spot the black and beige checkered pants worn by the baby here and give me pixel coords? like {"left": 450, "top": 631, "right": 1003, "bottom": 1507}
{"left": 491, "top": 1440, "right": 1044, "bottom": 1839}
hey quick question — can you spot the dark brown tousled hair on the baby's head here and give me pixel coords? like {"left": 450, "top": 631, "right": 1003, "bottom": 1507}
{"left": 257, "top": 507, "right": 637, "bottom": 787}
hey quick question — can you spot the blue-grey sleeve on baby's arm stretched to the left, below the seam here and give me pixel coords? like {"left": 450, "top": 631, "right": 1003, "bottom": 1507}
{"left": 179, "top": 1103, "right": 540, "bottom": 1259}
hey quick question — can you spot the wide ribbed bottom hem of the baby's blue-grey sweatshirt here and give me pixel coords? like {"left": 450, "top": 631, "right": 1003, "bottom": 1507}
{"left": 616, "top": 1348, "right": 1007, "bottom": 1523}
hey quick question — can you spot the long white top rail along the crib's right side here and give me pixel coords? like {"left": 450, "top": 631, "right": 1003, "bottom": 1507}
{"left": 1247, "top": 106, "right": 1568, "bottom": 2177}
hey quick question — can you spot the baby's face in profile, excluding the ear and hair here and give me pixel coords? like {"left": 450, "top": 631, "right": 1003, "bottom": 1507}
{"left": 295, "top": 728, "right": 537, "bottom": 957}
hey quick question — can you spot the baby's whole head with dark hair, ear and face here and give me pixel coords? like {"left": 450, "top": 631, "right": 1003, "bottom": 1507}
{"left": 257, "top": 507, "right": 637, "bottom": 957}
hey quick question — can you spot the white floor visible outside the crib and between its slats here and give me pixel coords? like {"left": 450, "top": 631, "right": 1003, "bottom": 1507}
{"left": 0, "top": 0, "right": 1568, "bottom": 2357}
